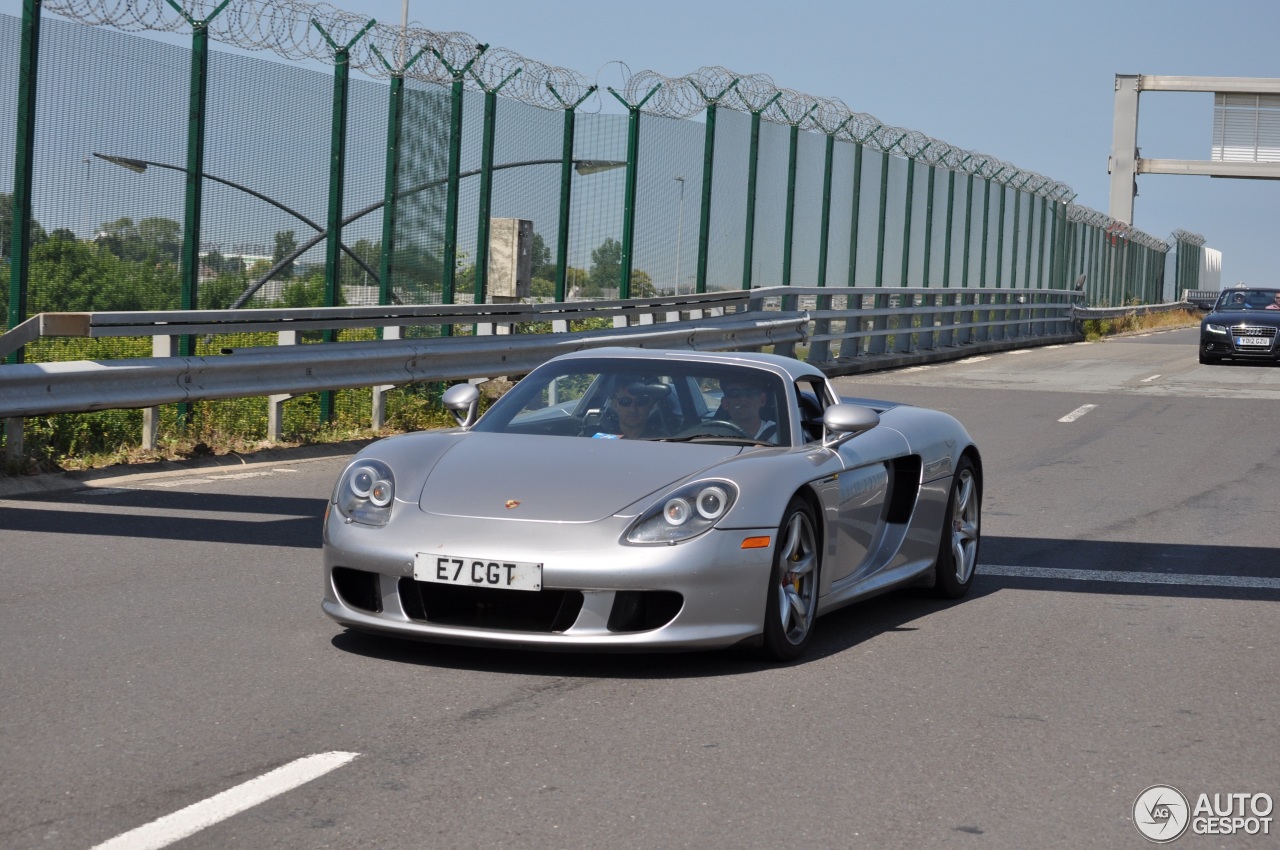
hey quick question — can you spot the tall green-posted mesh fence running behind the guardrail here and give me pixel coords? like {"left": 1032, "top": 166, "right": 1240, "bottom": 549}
{"left": 0, "top": 0, "right": 1203, "bottom": 465}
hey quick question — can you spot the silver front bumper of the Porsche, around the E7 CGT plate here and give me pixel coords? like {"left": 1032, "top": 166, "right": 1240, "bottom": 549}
{"left": 323, "top": 506, "right": 777, "bottom": 650}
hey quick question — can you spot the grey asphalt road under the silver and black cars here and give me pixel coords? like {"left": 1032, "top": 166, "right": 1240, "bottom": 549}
{"left": 0, "top": 326, "right": 1280, "bottom": 850}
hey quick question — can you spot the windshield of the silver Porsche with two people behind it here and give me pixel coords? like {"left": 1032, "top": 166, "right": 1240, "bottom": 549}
{"left": 474, "top": 357, "right": 791, "bottom": 445}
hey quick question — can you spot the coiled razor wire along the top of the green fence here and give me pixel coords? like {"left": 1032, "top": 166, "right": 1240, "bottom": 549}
{"left": 44, "top": 0, "right": 1090, "bottom": 208}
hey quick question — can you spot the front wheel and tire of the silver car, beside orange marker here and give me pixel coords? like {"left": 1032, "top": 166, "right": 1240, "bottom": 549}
{"left": 762, "top": 498, "right": 820, "bottom": 661}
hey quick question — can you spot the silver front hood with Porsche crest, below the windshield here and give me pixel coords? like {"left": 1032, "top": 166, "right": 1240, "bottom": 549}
{"left": 419, "top": 433, "right": 742, "bottom": 522}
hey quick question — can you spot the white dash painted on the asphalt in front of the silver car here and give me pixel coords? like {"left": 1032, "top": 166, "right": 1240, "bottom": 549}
{"left": 92, "top": 753, "right": 360, "bottom": 850}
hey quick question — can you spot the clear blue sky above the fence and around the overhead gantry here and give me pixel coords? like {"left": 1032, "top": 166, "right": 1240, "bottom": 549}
{"left": 10, "top": 0, "right": 1280, "bottom": 284}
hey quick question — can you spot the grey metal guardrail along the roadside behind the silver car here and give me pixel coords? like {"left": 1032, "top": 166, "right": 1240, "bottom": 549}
{"left": 0, "top": 287, "right": 1095, "bottom": 456}
